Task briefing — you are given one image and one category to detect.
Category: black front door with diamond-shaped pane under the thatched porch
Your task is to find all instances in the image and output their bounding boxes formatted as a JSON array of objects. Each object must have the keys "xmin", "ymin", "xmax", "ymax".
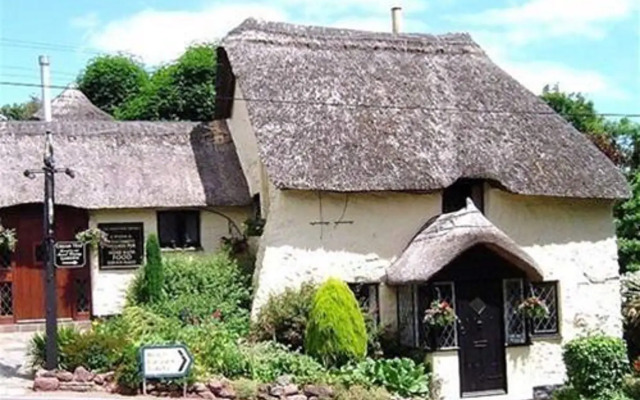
[{"xmin": 456, "ymin": 281, "xmax": 507, "ymax": 395}]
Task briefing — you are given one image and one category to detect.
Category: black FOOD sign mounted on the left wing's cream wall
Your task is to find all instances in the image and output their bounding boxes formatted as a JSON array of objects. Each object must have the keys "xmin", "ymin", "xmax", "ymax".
[{"xmin": 98, "ymin": 223, "xmax": 144, "ymax": 269}]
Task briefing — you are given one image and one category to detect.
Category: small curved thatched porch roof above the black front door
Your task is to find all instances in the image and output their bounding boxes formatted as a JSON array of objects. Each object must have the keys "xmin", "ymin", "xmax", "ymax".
[{"xmin": 387, "ymin": 200, "xmax": 542, "ymax": 285}]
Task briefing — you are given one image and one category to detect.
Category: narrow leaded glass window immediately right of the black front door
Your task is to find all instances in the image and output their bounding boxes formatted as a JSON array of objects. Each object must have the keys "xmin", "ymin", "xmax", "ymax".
[{"xmin": 502, "ymin": 279, "xmax": 527, "ymax": 345}]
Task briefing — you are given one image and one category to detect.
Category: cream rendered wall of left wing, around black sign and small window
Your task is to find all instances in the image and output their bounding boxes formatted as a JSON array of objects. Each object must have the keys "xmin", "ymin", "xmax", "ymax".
[{"xmin": 89, "ymin": 207, "xmax": 251, "ymax": 316}]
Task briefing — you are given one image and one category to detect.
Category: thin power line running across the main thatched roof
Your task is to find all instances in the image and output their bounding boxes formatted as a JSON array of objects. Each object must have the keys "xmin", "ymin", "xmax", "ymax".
[{"xmin": 0, "ymin": 81, "xmax": 640, "ymax": 118}]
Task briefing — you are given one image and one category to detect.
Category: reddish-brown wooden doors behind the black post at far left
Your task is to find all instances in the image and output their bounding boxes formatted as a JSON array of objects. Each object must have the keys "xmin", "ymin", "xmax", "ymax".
[{"xmin": 0, "ymin": 205, "xmax": 90, "ymax": 322}]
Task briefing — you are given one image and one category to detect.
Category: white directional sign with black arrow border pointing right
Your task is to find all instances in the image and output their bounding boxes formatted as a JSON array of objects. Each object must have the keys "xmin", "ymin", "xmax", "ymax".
[{"xmin": 141, "ymin": 345, "xmax": 193, "ymax": 378}]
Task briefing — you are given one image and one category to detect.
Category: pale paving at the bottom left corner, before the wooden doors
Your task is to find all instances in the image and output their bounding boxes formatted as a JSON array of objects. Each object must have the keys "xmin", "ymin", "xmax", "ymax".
[{"xmin": 0, "ymin": 332, "xmax": 33, "ymax": 398}]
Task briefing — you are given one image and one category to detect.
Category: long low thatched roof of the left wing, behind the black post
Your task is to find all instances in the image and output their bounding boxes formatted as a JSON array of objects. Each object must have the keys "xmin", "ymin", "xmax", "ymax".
[{"xmin": 0, "ymin": 121, "xmax": 250, "ymax": 209}]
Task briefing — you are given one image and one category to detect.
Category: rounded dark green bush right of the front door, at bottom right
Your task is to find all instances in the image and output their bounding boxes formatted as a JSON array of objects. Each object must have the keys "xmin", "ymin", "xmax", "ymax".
[{"xmin": 563, "ymin": 335, "xmax": 630, "ymax": 398}]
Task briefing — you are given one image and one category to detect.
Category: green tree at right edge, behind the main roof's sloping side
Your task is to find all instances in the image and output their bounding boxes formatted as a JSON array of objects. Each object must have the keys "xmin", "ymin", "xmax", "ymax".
[{"xmin": 541, "ymin": 86, "xmax": 640, "ymax": 273}]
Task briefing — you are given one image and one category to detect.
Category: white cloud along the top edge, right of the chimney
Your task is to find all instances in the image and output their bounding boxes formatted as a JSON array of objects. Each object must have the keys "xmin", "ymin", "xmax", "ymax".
[{"xmin": 450, "ymin": 0, "xmax": 638, "ymax": 44}]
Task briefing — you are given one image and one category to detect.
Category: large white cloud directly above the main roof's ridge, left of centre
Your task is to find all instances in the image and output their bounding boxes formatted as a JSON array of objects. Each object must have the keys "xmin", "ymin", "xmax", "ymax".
[{"xmin": 79, "ymin": 0, "xmax": 426, "ymax": 65}]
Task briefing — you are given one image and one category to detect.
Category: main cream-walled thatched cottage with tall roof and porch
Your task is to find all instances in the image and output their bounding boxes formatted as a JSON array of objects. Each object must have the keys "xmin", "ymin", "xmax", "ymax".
[{"xmin": 217, "ymin": 20, "xmax": 629, "ymax": 400}]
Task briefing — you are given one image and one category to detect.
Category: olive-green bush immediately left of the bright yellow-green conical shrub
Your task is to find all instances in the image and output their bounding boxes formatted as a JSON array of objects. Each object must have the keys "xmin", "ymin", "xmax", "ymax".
[{"xmin": 251, "ymin": 283, "xmax": 317, "ymax": 350}]
